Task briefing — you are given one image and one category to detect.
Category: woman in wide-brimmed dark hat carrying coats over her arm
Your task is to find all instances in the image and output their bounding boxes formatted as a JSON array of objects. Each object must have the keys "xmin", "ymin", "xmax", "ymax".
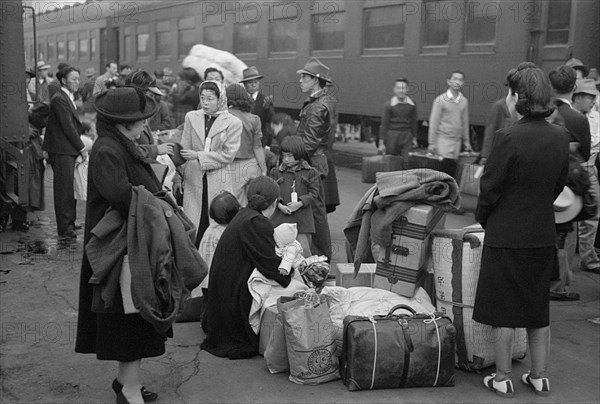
[{"xmin": 75, "ymin": 87, "xmax": 165, "ymax": 403}]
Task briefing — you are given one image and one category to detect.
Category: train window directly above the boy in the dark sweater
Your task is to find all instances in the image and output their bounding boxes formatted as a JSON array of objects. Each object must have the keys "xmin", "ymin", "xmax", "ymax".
[{"xmin": 363, "ymin": 5, "xmax": 405, "ymax": 49}]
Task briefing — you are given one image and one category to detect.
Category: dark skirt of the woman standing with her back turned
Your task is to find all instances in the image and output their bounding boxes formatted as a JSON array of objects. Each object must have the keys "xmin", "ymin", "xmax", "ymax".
[{"xmin": 473, "ymin": 245, "xmax": 557, "ymax": 328}]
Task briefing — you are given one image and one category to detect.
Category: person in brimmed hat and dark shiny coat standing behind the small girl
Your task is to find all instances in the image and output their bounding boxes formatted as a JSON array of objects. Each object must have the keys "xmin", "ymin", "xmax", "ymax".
[{"xmin": 296, "ymin": 57, "xmax": 339, "ymax": 257}]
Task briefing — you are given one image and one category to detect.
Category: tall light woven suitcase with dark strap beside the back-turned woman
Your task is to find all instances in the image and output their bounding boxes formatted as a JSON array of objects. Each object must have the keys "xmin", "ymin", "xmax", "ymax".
[{"xmin": 432, "ymin": 225, "xmax": 527, "ymax": 370}]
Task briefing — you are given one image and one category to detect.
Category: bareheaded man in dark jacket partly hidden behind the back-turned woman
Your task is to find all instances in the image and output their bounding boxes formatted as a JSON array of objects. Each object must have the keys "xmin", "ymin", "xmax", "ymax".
[{"xmin": 548, "ymin": 65, "xmax": 591, "ymax": 301}]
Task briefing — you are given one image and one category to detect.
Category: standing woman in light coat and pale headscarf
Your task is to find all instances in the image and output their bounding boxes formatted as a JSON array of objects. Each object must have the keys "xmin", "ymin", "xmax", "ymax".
[{"xmin": 181, "ymin": 80, "xmax": 242, "ymax": 245}]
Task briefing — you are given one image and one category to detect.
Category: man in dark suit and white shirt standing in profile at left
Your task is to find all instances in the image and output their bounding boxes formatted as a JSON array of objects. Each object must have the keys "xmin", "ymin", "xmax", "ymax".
[{"xmin": 43, "ymin": 67, "xmax": 87, "ymax": 238}]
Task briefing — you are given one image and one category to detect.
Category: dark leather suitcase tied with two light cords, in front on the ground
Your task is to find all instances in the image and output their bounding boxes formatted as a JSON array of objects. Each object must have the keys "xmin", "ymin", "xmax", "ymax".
[{"xmin": 341, "ymin": 304, "xmax": 456, "ymax": 391}]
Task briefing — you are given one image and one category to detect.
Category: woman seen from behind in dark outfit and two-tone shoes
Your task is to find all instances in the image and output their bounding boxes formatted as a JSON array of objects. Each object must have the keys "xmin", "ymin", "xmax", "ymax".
[{"xmin": 473, "ymin": 66, "xmax": 569, "ymax": 397}]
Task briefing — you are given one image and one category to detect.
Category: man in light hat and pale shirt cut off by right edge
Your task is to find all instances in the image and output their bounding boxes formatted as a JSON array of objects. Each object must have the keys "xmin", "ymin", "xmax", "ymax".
[{"xmin": 573, "ymin": 79, "xmax": 600, "ymax": 274}]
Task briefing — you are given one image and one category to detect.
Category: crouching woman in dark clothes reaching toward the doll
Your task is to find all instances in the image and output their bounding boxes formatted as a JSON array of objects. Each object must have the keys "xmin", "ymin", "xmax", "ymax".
[{"xmin": 201, "ymin": 176, "xmax": 293, "ymax": 359}]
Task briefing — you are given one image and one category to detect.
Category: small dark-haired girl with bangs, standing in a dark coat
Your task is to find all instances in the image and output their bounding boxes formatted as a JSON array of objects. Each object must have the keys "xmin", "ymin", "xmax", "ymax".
[{"xmin": 270, "ymin": 136, "xmax": 321, "ymax": 256}]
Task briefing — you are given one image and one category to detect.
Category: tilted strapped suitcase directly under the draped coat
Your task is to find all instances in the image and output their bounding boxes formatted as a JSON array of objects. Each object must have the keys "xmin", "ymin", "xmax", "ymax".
[{"xmin": 373, "ymin": 204, "xmax": 445, "ymax": 297}]
